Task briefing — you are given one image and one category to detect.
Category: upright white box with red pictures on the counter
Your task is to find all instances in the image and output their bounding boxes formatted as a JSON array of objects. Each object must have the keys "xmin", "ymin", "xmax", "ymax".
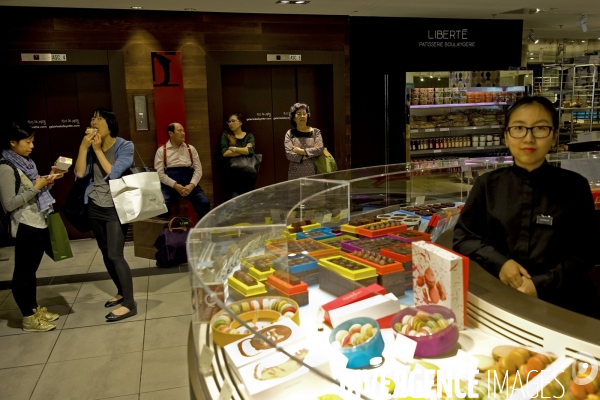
[{"xmin": 412, "ymin": 241, "xmax": 469, "ymax": 326}]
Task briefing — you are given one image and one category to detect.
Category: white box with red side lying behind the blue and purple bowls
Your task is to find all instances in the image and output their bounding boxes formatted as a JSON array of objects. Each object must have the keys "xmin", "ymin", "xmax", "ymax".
[{"xmin": 329, "ymin": 293, "xmax": 400, "ymax": 329}]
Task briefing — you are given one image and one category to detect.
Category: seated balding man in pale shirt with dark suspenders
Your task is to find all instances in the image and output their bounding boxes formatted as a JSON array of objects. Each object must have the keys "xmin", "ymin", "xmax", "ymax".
[{"xmin": 154, "ymin": 122, "xmax": 210, "ymax": 221}]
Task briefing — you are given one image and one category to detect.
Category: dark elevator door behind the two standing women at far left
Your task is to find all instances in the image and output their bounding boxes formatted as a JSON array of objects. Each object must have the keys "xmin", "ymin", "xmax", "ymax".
[{"xmin": 2, "ymin": 66, "xmax": 111, "ymax": 239}]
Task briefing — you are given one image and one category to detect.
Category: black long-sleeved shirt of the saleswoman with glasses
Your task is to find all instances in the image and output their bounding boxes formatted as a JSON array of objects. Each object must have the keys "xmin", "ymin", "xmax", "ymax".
[{"xmin": 453, "ymin": 162, "xmax": 600, "ymax": 314}]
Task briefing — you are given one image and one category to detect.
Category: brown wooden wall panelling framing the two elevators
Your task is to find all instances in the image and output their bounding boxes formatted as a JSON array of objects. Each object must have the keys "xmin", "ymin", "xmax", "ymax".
[{"xmin": 0, "ymin": 7, "xmax": 350, "ymax": 209}]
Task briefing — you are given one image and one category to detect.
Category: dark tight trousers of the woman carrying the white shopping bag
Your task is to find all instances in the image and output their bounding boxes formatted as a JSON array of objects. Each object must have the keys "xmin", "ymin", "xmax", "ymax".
[{"xmin": 87, "ymin": 200, "xmax": 135, "ymax": 310}]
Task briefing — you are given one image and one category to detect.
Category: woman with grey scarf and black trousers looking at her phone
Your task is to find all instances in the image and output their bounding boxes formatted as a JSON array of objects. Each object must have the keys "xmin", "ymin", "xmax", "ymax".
[{"xmin": 0, "ymin": 121, "xmax": 66, "ymax": 332}]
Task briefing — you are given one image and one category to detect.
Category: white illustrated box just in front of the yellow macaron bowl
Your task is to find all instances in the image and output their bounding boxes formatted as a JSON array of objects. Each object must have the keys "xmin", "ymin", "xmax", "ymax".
[{"xmin": 223, "ymin": 318, "xmax": 306, "ymax": 368}]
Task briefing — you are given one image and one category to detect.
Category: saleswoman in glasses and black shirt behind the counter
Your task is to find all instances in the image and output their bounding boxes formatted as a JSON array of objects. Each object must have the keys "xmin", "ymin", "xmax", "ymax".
[{"xmin": 454, "ymin": 97, "xmax": 600, "ymax": 318}]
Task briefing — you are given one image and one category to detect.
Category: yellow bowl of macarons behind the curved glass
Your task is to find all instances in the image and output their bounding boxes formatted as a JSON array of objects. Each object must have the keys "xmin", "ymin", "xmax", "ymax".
[{"xmin": 210, "ymin": 296, "xmax": 300, "ymax": 347}]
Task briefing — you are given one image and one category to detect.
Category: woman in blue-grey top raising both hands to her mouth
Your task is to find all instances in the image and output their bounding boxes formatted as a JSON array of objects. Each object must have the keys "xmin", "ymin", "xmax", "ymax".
[{"xmin": 75, "ymin": 108, "xmax": 137, "ymax": 322}]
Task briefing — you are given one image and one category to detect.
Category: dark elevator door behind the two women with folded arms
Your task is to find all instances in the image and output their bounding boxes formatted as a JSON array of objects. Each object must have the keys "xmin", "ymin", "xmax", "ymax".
[{"xmin": 218, "ymin": 65, "xmax": 334, "ymax": 188}]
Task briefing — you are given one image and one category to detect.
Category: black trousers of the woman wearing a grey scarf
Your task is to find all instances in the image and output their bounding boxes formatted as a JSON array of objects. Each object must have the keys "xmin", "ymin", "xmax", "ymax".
[{"xmin": 12, "ymin": 224, "xmax": 52, "ymax": 317}]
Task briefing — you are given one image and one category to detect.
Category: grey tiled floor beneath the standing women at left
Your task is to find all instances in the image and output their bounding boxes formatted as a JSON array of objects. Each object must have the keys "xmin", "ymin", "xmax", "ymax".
[{"xmin": 0, "ymin": 241, "xmax": 191, "ymax": 400}]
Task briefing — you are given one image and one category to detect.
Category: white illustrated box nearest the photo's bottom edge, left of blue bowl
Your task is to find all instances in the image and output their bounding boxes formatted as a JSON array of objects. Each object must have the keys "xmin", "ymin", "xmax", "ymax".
[{"xmin": 240, "ymin": 341, "xmax": 331, "ymax": 400}]
